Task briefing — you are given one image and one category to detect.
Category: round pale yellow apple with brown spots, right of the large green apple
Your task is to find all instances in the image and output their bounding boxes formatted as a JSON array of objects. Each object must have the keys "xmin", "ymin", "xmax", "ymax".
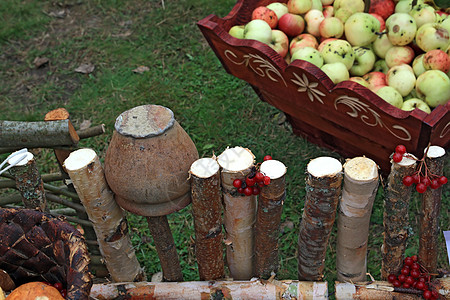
[{"xmin": 386, "ymin": 13, "xmax": 417, "ymax": 46}]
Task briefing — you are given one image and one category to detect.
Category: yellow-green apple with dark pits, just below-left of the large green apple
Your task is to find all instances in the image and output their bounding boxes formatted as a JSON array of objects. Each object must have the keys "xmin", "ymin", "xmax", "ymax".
[{"xmin": 320, "ymin": 39, "xmax": 355, "ymax": 70}]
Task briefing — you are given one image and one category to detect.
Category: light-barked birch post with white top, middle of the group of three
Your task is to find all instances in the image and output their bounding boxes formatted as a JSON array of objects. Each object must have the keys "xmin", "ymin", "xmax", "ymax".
[{"xmin": 217, "ymin": 147, "xmax": 256, "ymax": 280}]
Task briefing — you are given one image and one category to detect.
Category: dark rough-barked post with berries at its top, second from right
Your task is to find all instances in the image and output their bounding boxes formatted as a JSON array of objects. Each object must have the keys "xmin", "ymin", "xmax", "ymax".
[{"xmin": 381, "ymin": 154, "xmax": 417, "ymax": 280}]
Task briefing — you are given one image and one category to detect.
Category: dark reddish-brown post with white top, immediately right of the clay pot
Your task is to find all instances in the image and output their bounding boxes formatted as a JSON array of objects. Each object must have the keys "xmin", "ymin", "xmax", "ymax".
[{"xmin": 190, "ymin": 158, "xmax": 225, "ymax": 280}]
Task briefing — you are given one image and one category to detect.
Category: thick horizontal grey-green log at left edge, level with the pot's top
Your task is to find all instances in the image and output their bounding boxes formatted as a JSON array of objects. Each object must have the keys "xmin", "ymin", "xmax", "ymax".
[{"xmin": 0, "ymin": 120, "xmax": 80, "ymax": 148}]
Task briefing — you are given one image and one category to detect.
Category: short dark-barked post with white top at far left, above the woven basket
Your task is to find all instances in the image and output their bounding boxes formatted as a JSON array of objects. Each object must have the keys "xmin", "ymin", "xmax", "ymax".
[{"xmin": 8, "ymin": 152, "xmax": 47, "ymax": 211}]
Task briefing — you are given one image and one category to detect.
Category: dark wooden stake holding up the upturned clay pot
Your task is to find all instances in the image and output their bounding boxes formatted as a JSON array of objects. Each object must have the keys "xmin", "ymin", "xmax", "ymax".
[{"xmin": 147, "ymin": 216, "xmax": 183, "ymax": 281}]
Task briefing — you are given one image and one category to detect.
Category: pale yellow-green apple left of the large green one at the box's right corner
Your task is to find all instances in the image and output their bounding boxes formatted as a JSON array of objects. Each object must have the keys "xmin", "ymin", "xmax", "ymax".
[{"xmin": 386, "ymin": 64, "xmax": 416, "ymax": 97}]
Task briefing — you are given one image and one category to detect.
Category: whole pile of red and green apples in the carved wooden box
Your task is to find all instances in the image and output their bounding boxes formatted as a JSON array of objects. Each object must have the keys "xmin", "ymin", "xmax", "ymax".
[{"xmin": 229, "ymin": 0, "xmax": 450, "ymax": 113}]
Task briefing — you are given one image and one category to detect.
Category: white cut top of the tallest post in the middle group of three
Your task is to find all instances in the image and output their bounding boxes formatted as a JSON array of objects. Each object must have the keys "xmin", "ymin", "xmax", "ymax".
[{"xmin": 217, "ymin": 146, "xmax": 255, "ymax": 172}]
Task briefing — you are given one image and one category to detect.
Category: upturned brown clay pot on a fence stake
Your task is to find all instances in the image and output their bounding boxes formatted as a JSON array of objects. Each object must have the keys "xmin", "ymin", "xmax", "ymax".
[{"xmin": 105, "ymin": 105, "xmax": 198, "ymax": 216}]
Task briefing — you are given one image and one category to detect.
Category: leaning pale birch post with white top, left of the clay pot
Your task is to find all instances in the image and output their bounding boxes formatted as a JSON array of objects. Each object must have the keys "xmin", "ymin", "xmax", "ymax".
[{"xmin": 64, "ymin": 149, "xmax": 145, "ymax": 281}]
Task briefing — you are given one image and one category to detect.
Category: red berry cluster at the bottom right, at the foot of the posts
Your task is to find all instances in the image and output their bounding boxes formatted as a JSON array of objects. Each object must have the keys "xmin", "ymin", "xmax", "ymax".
[{"xmin": 388, "ymin": 255, "xmax": 439, "ymax": 300}]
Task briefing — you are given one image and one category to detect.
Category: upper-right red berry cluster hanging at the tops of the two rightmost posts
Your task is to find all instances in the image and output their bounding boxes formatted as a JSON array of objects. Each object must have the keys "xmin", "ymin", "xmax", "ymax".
[{"xmin": 392, "ymin": 145, "xmax": 448, "ymax": 194}]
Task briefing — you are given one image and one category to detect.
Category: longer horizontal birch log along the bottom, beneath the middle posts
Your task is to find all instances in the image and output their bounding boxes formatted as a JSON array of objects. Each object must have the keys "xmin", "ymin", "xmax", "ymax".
[{"xmin": 90, "ymin": 280, "xmax": 328, "ymax": 300}]
